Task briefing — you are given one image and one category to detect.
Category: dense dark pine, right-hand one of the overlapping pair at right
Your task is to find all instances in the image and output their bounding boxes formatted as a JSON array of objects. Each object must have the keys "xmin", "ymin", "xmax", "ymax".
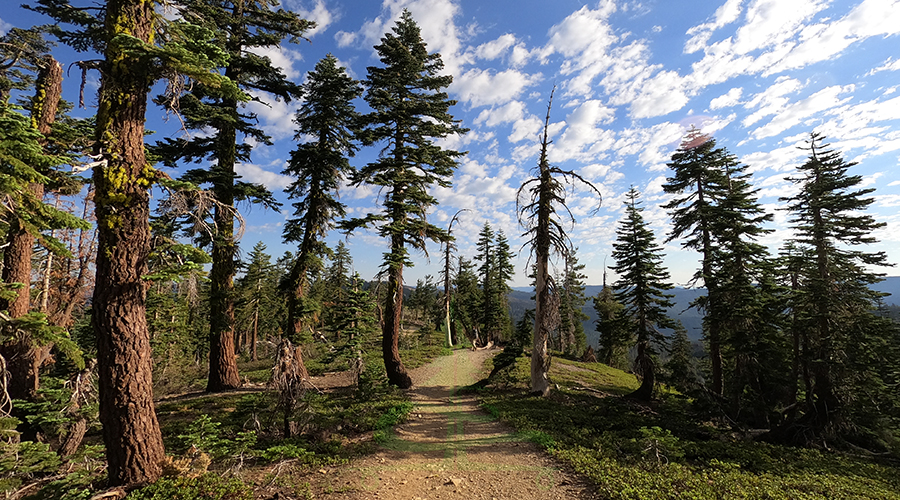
[{"xmin": 707, "ymin": 153, "xmax": 786, "ymax": 426}]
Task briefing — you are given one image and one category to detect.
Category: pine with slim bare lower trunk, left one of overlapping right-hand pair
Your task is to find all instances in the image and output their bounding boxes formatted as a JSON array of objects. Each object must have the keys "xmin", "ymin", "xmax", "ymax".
[{"xmin": 663, "ymin": 128, "xmax": 730, "ymax": 395}]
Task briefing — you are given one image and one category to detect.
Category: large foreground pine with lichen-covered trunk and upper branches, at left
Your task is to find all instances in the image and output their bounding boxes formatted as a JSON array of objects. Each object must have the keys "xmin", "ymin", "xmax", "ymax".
[{"xmin": 34, "ymin": 0, "xmax": 237, "ymax": 485}]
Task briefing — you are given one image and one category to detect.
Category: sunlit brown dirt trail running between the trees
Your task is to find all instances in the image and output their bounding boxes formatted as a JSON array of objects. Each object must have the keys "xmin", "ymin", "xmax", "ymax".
[{"xmin": 311, "ymin": 350, "xmax": 591, "ymax": 500}]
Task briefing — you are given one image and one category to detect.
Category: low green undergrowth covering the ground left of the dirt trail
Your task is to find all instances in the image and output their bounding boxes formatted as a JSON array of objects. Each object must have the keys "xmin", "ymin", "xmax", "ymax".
[{"xmin": 157, "ymin": 331, "xmax": 452, "ymax": 471}]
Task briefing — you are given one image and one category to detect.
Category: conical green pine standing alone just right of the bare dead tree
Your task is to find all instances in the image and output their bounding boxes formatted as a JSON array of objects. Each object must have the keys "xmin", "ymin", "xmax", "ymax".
[{"xmin": 612, "ymin": 186, "xmax": 675, "ymax": 400}]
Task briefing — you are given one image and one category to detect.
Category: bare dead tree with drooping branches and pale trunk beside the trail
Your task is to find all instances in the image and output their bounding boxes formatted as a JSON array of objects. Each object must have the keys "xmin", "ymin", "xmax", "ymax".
[{"xmin": 516, "ymin": 87, "xmax": 602, "ymax": 396}]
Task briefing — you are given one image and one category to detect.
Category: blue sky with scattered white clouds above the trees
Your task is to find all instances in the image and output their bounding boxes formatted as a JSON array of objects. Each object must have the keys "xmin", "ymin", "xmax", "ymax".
[{"xmin": 0, "ymin": 0, "xmax": 900, "ymax": 286}]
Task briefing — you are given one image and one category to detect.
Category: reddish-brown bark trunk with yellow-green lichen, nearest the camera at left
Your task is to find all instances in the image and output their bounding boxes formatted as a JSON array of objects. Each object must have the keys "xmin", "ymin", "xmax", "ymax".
[{"xmin": 91, "ymin": 0, "xmax": 165, "ymax": 485}]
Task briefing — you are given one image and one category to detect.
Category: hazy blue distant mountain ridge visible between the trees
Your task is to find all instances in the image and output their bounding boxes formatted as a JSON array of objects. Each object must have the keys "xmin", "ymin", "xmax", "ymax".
[{"xmin": 508, "ymin": 276, "xmax": 900, "ymax": 346}]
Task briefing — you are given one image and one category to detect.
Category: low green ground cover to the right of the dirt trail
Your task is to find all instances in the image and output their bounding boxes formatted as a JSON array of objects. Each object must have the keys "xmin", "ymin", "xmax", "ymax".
[{"xmin": 480, "ymin": 357, "xmax": 900, "ymax": 500}]
